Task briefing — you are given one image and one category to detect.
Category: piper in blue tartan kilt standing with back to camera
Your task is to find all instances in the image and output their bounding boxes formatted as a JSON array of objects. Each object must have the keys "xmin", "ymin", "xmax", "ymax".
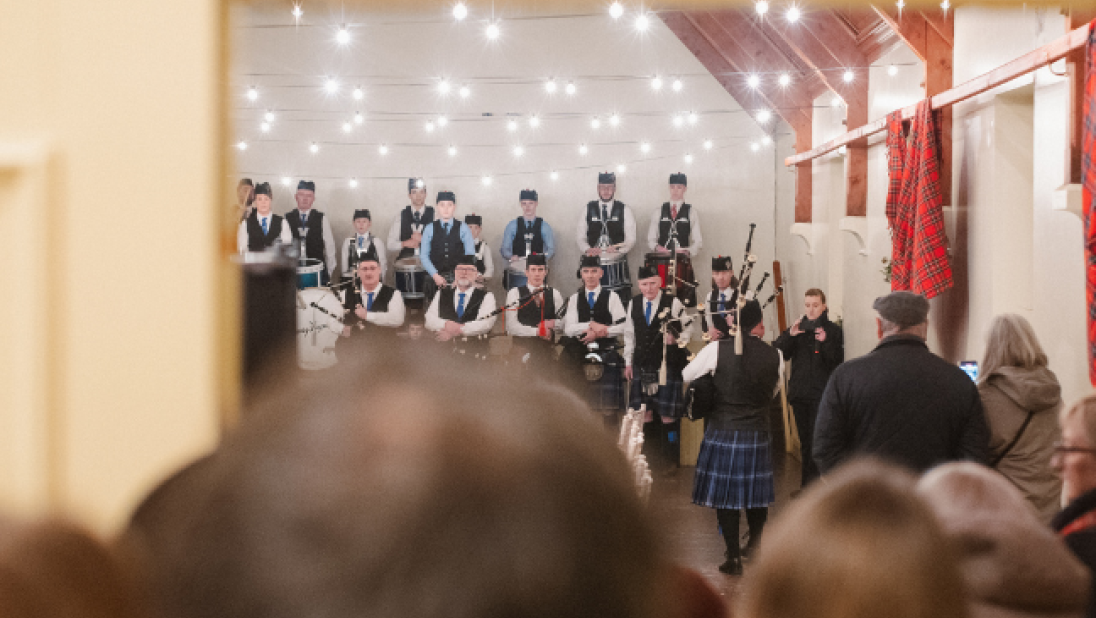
[{"xmin": 683, "ymin": 300, "xmax": 784, "ymax": 575}]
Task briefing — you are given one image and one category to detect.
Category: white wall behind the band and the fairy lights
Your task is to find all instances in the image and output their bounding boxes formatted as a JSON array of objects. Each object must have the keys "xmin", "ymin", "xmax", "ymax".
[{"xmin": 232, "ymin": 9, "xmax": 786, "ymax": 306}]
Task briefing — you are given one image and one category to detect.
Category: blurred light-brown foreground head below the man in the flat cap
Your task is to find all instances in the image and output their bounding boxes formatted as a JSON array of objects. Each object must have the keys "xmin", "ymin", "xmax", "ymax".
[{"xmin": 735, "ymin": 460, "xmax": 967, "ymax": 618}]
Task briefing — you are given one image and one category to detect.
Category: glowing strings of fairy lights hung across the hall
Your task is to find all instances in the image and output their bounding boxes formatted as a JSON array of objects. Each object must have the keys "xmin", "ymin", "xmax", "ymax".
[{"xmin": 235, "ymin": 0, "xmax": 933, "ymax": 182}]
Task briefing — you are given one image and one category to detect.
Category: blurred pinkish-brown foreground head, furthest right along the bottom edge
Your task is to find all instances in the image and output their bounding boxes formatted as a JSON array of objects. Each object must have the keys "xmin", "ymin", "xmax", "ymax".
[{"xmin": 917, "ymin": 462, "xmax": 1088, "ymax": 617}]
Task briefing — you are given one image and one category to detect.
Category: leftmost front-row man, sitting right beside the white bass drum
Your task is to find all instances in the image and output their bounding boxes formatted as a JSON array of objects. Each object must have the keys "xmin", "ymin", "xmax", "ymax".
[{"xmin": 342, "ymin": 253, "xmax": 407, "ymax": 345}]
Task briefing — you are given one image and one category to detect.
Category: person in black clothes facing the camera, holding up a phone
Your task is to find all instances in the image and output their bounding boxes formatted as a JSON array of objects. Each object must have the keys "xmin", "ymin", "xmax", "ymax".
[{"xmin": 773, "ymin": 288, "xmax": 845, "ymax": 487}]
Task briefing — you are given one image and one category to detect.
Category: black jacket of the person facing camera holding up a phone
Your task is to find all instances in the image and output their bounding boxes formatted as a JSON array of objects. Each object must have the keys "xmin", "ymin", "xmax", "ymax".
[{"xmin": 773, "ymin": 311, "xmax": 845, "ymax": 401}]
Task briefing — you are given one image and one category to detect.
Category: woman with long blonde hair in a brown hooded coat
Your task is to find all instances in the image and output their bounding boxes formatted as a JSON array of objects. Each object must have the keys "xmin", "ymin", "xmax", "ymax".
[{"xmin": 978, "ymin": 313, "xmax": 1062, "ymax": 524}]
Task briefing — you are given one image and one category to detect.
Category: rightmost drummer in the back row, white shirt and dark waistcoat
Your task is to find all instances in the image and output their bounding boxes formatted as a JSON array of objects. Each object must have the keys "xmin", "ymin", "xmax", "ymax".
[{"xmin": 647, "ymin": 172, "xmax": 704, "ymax": 307}]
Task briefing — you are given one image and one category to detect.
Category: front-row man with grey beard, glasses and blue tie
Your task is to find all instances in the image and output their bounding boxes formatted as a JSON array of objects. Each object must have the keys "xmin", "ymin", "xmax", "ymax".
[{"xmin": 426, "ymin": 253, "xmax": 498, "ymax": 358}]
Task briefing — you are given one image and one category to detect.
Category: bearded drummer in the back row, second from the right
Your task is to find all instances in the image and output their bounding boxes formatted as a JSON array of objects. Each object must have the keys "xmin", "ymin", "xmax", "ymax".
[{"xmin": 575, "ymin": 172, "xmax": 636, "ymax": 302}]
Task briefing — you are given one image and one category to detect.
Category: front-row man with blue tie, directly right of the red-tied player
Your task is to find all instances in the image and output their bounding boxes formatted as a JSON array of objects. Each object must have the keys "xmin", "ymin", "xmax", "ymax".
[{"xmin": 563, "ymin": 255, "xmax": 627, "ymax": 422}]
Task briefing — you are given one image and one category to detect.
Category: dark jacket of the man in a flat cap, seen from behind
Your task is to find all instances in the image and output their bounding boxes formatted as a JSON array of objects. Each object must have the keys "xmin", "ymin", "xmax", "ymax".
[{"xmin": 814, "ymin": 335, "xmax": 990, "ymax": 473}]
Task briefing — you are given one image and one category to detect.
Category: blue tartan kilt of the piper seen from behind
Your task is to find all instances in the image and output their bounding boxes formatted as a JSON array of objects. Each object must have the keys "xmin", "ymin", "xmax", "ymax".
[{"xmin": 693, "ymin": 427, "xmax": 776, "ymax": 508}]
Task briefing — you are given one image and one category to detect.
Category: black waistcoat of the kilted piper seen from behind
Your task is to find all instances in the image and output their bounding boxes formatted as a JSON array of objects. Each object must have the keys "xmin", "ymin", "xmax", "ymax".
[{"xmin": 711, "ymin": 335, "xmax": 780, "ymax": 432}]
